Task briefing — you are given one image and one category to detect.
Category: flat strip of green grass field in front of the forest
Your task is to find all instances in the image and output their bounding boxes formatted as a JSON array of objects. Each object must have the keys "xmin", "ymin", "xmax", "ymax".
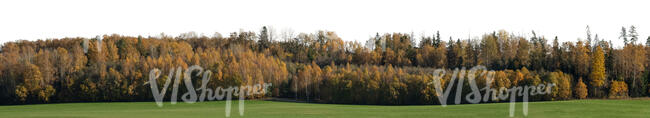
[{"xmin": 0, "ymin": 100, "xmax": 650, "ymax": 118}]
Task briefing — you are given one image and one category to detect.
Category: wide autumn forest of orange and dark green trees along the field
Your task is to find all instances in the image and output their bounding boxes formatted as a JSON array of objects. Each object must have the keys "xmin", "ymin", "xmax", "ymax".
[{"xmin": 0, "ymin": 27, "xmax": 650, "ymax": 104}]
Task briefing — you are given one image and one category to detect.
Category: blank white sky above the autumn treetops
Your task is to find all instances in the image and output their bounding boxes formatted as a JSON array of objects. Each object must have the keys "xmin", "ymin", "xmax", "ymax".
[{"xmin": 0, "ymin": 0, "xmax": 650, "ymax": 46}]
